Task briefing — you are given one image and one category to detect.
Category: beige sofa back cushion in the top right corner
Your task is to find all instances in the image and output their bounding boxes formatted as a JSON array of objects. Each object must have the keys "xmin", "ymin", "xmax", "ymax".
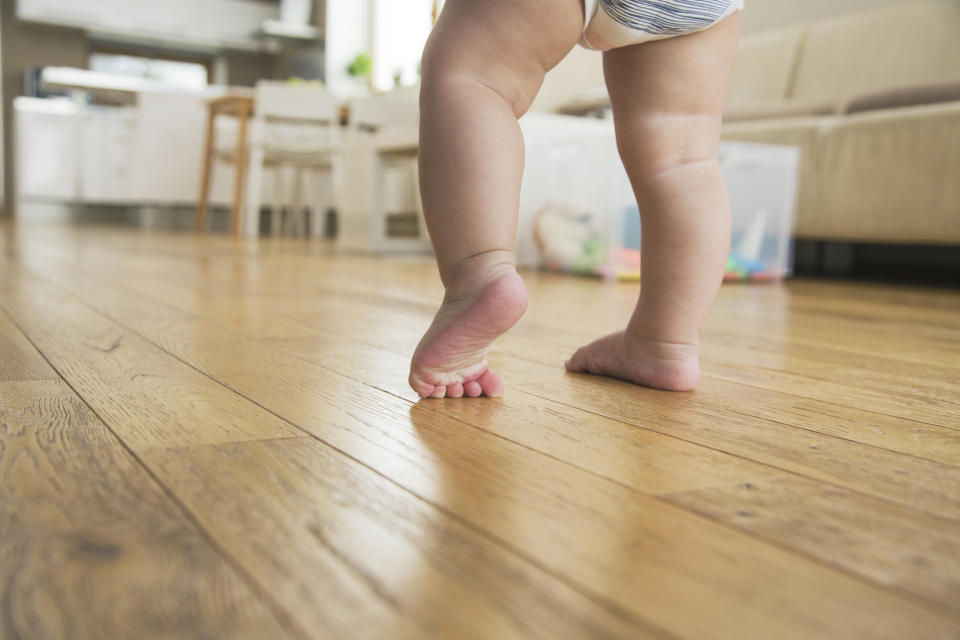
[{"xmin": 791, "ymin": 0, "xmax": 960, "ymax": 99}]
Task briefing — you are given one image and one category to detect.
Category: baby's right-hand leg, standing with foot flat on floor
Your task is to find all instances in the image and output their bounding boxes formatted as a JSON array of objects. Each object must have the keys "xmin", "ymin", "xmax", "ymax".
[{"xmin": 567, "ymin": 14, "xmax": 739, "ymax": 391}]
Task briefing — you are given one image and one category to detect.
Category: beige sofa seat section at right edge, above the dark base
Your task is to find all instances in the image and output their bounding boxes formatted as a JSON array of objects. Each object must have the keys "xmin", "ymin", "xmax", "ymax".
[{"xmin": 804, "ymin": 102, "xmax": 960, "ymax": 244}]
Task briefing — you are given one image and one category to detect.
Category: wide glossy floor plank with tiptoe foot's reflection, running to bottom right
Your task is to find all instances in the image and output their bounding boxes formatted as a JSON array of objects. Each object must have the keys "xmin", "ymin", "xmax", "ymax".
[{"xmin": 13, "ymin": 258, "xmax": 956, "ymax": 637}]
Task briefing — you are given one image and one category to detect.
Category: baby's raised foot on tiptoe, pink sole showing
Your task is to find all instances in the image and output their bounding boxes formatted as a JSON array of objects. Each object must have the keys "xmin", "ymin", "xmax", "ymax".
[{"xmin": 409, "ymin": 265, "xmax": 527, "ymax": 398}]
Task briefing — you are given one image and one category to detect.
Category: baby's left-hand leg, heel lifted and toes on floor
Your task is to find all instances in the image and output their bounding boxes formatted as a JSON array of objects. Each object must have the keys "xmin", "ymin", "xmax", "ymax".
[{"xmin": 410, "ymin": 0, "xmax": 583, "ymax": 397}]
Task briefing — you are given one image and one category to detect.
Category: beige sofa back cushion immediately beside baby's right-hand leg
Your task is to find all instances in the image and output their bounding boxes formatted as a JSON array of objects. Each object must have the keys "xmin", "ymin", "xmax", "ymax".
[{"xmin": 727, "ymin": 25, "xmax": 806, "ymax": 106}]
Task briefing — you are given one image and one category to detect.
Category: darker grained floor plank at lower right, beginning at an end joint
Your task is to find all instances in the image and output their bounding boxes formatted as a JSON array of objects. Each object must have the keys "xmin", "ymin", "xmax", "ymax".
[{"xmin": 670, "ymin": 476, "xmax": 960, "ymax": 611}]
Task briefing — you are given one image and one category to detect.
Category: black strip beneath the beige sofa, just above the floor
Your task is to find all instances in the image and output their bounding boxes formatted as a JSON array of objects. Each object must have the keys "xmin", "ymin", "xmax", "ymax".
[{"xmin": 793, "ymin": 239, "xmax": 960, "ymax": 289}]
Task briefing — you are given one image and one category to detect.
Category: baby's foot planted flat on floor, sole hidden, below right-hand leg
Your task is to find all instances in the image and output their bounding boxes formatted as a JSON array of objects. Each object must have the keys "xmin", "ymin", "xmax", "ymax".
[{"xmin": 565, "ymin": 331, "xmax": 700, "ymax": 391}]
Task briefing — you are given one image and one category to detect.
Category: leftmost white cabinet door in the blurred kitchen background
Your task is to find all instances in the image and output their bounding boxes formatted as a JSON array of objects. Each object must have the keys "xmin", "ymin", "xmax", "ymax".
[{"xmin": 16, "ymin": 111, "xmax": 79, "ymax": 200}]
